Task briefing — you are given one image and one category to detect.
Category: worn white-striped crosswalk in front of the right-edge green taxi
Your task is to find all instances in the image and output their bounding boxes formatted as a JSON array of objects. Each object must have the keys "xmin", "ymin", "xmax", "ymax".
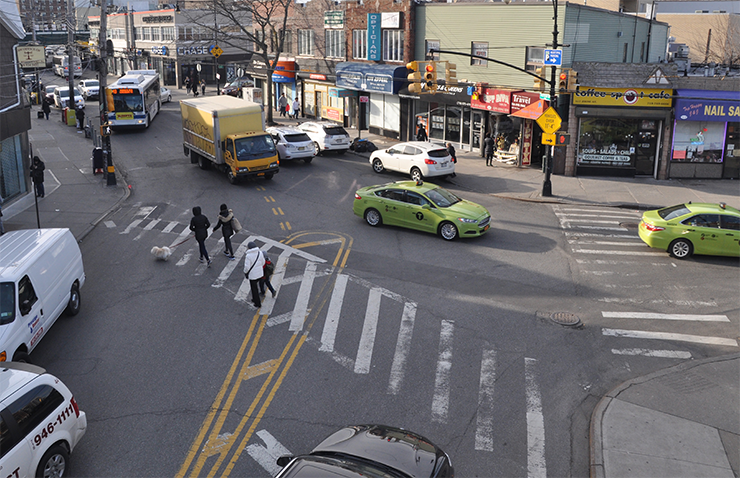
[{"xmin": 553, "ymin": 205, "xmax": 738, "ymax": 359}]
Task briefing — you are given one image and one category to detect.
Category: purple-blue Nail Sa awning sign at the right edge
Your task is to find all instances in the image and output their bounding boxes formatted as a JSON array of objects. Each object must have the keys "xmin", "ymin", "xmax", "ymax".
[{"xmin": 676, "ymin": 90, "xmax": 740, "ymax": 122}]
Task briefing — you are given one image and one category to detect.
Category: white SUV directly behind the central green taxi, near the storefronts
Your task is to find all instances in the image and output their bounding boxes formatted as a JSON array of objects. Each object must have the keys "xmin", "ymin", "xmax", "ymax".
[{"xmin": 370, "ymin": 141, "xmax": 455, "ymax": 181}]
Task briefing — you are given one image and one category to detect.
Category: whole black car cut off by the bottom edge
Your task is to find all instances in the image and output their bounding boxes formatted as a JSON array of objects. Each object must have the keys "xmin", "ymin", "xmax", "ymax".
[{"xmin": 275, "ymin": 425, "xmax": 455, "ymax": 478}]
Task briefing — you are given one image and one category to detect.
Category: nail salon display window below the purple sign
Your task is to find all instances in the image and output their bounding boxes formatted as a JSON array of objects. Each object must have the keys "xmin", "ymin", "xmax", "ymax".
[{"xmin": 671, "ymin": 121, "xmax": 725, "ymax": 163}]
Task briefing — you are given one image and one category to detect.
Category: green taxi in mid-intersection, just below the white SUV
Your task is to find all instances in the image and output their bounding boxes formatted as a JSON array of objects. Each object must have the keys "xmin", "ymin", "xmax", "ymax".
[{"xmin": 352, "ymin": 181, "xmax": 491, "ymax": 241}]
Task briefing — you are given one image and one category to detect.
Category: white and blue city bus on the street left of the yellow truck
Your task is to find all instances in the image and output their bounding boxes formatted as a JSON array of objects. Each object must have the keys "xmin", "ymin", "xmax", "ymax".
[{"xmin": 105, "ymin": 70, "xmax": 160, "ymax": 130}]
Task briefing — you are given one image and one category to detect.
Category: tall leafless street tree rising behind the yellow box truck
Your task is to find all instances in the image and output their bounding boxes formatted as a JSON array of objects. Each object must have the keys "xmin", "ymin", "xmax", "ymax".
[{"xmin": 186, "ymin": 0, "xmax": 294, "ymax": 125}]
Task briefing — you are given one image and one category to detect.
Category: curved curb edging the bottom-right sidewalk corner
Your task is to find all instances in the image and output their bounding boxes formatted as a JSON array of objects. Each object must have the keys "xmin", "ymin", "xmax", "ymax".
[{"xmin": 589, "ymin": 353, "xmax": 740, "ymax": 478}]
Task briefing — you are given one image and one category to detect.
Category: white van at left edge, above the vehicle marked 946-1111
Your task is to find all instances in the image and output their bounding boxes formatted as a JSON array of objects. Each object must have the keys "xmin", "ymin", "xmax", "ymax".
[{"xmin": 0, "ymin": 229, "xmax": 85, "ymax": 362}]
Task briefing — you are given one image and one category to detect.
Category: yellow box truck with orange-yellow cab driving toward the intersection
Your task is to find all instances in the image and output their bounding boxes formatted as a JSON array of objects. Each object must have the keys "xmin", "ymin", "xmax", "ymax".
[{"xmin": 180, "ymin": 95, "xmax": 280, "ymax": 184}]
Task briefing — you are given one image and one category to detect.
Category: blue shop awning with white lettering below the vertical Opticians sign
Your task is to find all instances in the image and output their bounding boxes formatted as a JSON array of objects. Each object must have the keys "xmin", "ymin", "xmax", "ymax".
[{"xmin": 336, "ymin": 61, "xmax": 408, "ymax": 95}]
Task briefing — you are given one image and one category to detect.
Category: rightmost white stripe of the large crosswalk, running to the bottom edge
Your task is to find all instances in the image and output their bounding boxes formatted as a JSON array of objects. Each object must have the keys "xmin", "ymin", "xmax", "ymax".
[{"xmin": 524, "ymin": 358, "xmax": 547, "ymax": 478}]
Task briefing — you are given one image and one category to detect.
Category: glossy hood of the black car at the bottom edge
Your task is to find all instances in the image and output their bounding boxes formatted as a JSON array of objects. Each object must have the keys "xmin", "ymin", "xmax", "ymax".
[{"xmin": 311, "ymin": 425, "xmax": 446, "ymax": 478}]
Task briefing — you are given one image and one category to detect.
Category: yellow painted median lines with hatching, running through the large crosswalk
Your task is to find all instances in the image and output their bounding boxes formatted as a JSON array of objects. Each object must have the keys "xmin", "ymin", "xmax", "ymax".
[{"xmin": 175, "ymin": 232, "xmax": 353, "ymax": 478}]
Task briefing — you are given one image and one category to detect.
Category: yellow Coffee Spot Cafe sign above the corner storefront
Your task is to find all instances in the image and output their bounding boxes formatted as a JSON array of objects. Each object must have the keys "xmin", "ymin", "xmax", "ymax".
[{"xmin": 573, "ymin": 88, "xmax": 673, "ymax": 108}]
